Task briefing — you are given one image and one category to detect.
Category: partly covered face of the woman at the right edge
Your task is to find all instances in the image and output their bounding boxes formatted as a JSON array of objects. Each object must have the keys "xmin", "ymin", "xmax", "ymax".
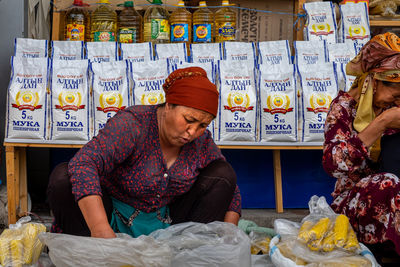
[{"xmin": 374, "ymin": 80, "xmax": 400, "ymax": 109}]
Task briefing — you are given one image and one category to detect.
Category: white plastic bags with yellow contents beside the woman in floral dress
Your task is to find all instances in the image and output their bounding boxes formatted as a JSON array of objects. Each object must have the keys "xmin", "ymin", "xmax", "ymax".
[{"xmin": 270, "ymin": 196, "xmax": 379, "ymax": 267}]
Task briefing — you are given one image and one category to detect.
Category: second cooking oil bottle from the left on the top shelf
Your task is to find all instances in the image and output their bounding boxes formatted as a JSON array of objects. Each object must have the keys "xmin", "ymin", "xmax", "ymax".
[{"xmin": 90, "ymin": 0, "xmax": 117, "ymax": 42}]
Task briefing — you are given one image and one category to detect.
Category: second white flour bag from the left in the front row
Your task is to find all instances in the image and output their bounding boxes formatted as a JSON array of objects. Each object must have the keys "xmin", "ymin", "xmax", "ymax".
[{"xmin": 50, "ymin": 60, "xmax": 90, "ymax": 141}]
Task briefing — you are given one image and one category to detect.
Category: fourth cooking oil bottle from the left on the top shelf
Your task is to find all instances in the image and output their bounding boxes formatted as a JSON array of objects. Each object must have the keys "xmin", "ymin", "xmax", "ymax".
[{"xmin": 143, "ymin": 0, "xmax": 170, "ymax": 43}]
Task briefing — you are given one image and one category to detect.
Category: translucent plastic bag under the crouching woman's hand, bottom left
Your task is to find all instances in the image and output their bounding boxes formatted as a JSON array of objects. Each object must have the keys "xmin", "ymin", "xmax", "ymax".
[{"xmin": 39, "ymin": 233, "xmax": 171, "ymax": 267}]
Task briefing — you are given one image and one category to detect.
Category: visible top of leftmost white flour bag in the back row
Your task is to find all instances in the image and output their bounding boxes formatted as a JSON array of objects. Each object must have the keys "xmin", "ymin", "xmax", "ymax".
[{"xmin": 14, "ymin": 38, "xmax": 48, "ymax": 58}]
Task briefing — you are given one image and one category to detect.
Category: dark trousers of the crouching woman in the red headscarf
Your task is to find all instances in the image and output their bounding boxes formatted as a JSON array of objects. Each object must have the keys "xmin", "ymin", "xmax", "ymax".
[{"xmin": 47, "ymin": 160, "xmax": 236, "ymax": 236}]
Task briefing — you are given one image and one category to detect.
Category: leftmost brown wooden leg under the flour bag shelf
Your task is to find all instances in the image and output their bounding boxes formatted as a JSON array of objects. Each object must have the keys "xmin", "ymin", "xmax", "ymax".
[{"xmin": 6, "ymin": 146, "xmax": 17, "ymax": 224}]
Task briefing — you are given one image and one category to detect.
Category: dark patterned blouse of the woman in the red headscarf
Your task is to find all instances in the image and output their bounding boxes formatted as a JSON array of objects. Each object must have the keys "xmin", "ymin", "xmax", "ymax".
[{"xmin": 68, "ymin": 106, "xmax": 241, "ymax": 214}]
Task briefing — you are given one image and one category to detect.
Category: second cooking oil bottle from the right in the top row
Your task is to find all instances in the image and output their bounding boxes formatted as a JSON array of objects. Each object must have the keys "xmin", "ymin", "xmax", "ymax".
[{"xmin": 193, "ymin": 1, "xmax": 214, "ymax": 43}]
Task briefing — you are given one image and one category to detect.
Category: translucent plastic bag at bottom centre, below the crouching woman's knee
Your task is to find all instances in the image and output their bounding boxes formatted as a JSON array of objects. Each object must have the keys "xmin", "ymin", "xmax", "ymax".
[{"xmin": 150, "ymin": 222, "xmax": 251, "ymax": 267}]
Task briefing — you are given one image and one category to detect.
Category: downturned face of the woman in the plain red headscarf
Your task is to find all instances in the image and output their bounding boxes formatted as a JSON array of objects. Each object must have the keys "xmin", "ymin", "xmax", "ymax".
[{"xmin": 161, "ymin": 103, "xmax": 214, "ymax": 147}]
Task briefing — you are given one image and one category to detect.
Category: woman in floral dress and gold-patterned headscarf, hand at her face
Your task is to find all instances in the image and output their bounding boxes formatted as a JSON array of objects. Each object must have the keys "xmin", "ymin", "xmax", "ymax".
[{"xmin": 323, "ymin": 33, "xmax": 400, "ymax": 254}]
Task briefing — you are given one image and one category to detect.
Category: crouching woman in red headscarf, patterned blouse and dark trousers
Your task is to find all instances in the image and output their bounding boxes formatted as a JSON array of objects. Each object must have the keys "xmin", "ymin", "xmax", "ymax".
[{"xmin": 48, "ymin": 67, "xmax": 241, "ymax": 238}]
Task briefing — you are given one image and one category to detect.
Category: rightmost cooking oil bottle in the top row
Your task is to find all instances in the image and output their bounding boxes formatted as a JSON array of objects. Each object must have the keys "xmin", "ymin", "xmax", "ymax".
[{"xmin": 215, "ymin": 0, "xmax": 236, "ymax": 43}]
